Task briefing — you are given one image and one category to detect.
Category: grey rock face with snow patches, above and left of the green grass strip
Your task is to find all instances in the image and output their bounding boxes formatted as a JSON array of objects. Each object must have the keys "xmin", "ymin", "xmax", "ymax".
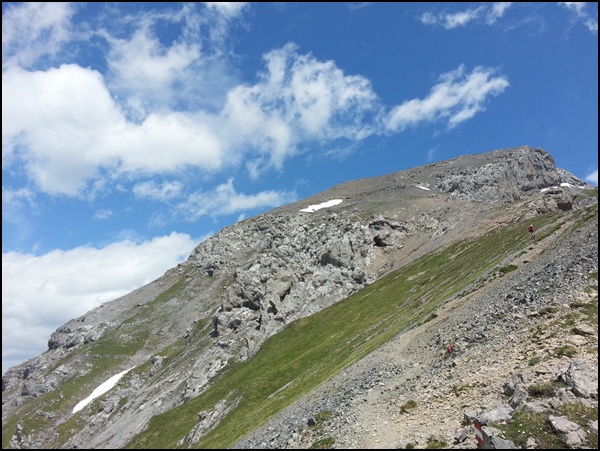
[{"xmin": 2, "ymin": 146, "xmax": 597, "ymax": 448}]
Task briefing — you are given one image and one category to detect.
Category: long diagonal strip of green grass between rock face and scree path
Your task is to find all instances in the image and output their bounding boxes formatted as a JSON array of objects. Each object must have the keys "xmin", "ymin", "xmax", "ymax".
[{"xmin": 128, "ymin": 215, "xmax": 557, "ymax": 449}]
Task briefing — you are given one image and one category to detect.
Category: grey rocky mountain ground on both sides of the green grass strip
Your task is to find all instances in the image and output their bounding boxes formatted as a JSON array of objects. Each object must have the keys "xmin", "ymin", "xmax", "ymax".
[{"xmin": 2, "ymin": 146, "xmax": 598, "ymax": 449}]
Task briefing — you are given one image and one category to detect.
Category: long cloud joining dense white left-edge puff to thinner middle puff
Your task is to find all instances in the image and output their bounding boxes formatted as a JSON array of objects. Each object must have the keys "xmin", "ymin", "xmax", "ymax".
[{"xmin": 2, "ymin": 41, "xmax": 376, "ymax": 196}]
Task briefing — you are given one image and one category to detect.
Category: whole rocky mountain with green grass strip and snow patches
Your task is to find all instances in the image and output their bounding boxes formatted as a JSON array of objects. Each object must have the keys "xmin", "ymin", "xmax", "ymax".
[{"xmin": 2, "ymin": 146, "xmax": 598, "ymax": 448}]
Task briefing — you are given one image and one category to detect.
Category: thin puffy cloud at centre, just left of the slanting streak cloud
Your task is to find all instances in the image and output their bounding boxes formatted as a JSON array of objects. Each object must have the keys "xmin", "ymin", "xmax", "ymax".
[{"xmin": 224, "ymin": 44, "xmax": 379, "ymax": 174}]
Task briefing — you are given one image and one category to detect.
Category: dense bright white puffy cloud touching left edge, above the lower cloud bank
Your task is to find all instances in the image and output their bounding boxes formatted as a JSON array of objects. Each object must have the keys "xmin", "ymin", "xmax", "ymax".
[{"xmin": 2, "ymin": 65, "xmax": 225, "ymax": 196}]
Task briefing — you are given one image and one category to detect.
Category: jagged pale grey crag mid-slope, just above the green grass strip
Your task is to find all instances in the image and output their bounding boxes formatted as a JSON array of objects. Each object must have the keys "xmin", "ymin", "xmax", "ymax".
[{"xmin": 213, "ymin": 214, "xmax": 374, "ymax": 358}]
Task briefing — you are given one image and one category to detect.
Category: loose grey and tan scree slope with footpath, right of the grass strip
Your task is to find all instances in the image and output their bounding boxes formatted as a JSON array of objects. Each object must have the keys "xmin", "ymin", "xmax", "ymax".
[{"xmin": 236, "ymin": 200, "xmax": 598, "ymax": 449}]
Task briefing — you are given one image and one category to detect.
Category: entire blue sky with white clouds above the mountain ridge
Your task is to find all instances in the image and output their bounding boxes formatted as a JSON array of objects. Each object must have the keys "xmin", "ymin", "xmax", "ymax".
[{"xmin": 2, "ymin": 2, "xmax": 598, "ymax": 373}]
